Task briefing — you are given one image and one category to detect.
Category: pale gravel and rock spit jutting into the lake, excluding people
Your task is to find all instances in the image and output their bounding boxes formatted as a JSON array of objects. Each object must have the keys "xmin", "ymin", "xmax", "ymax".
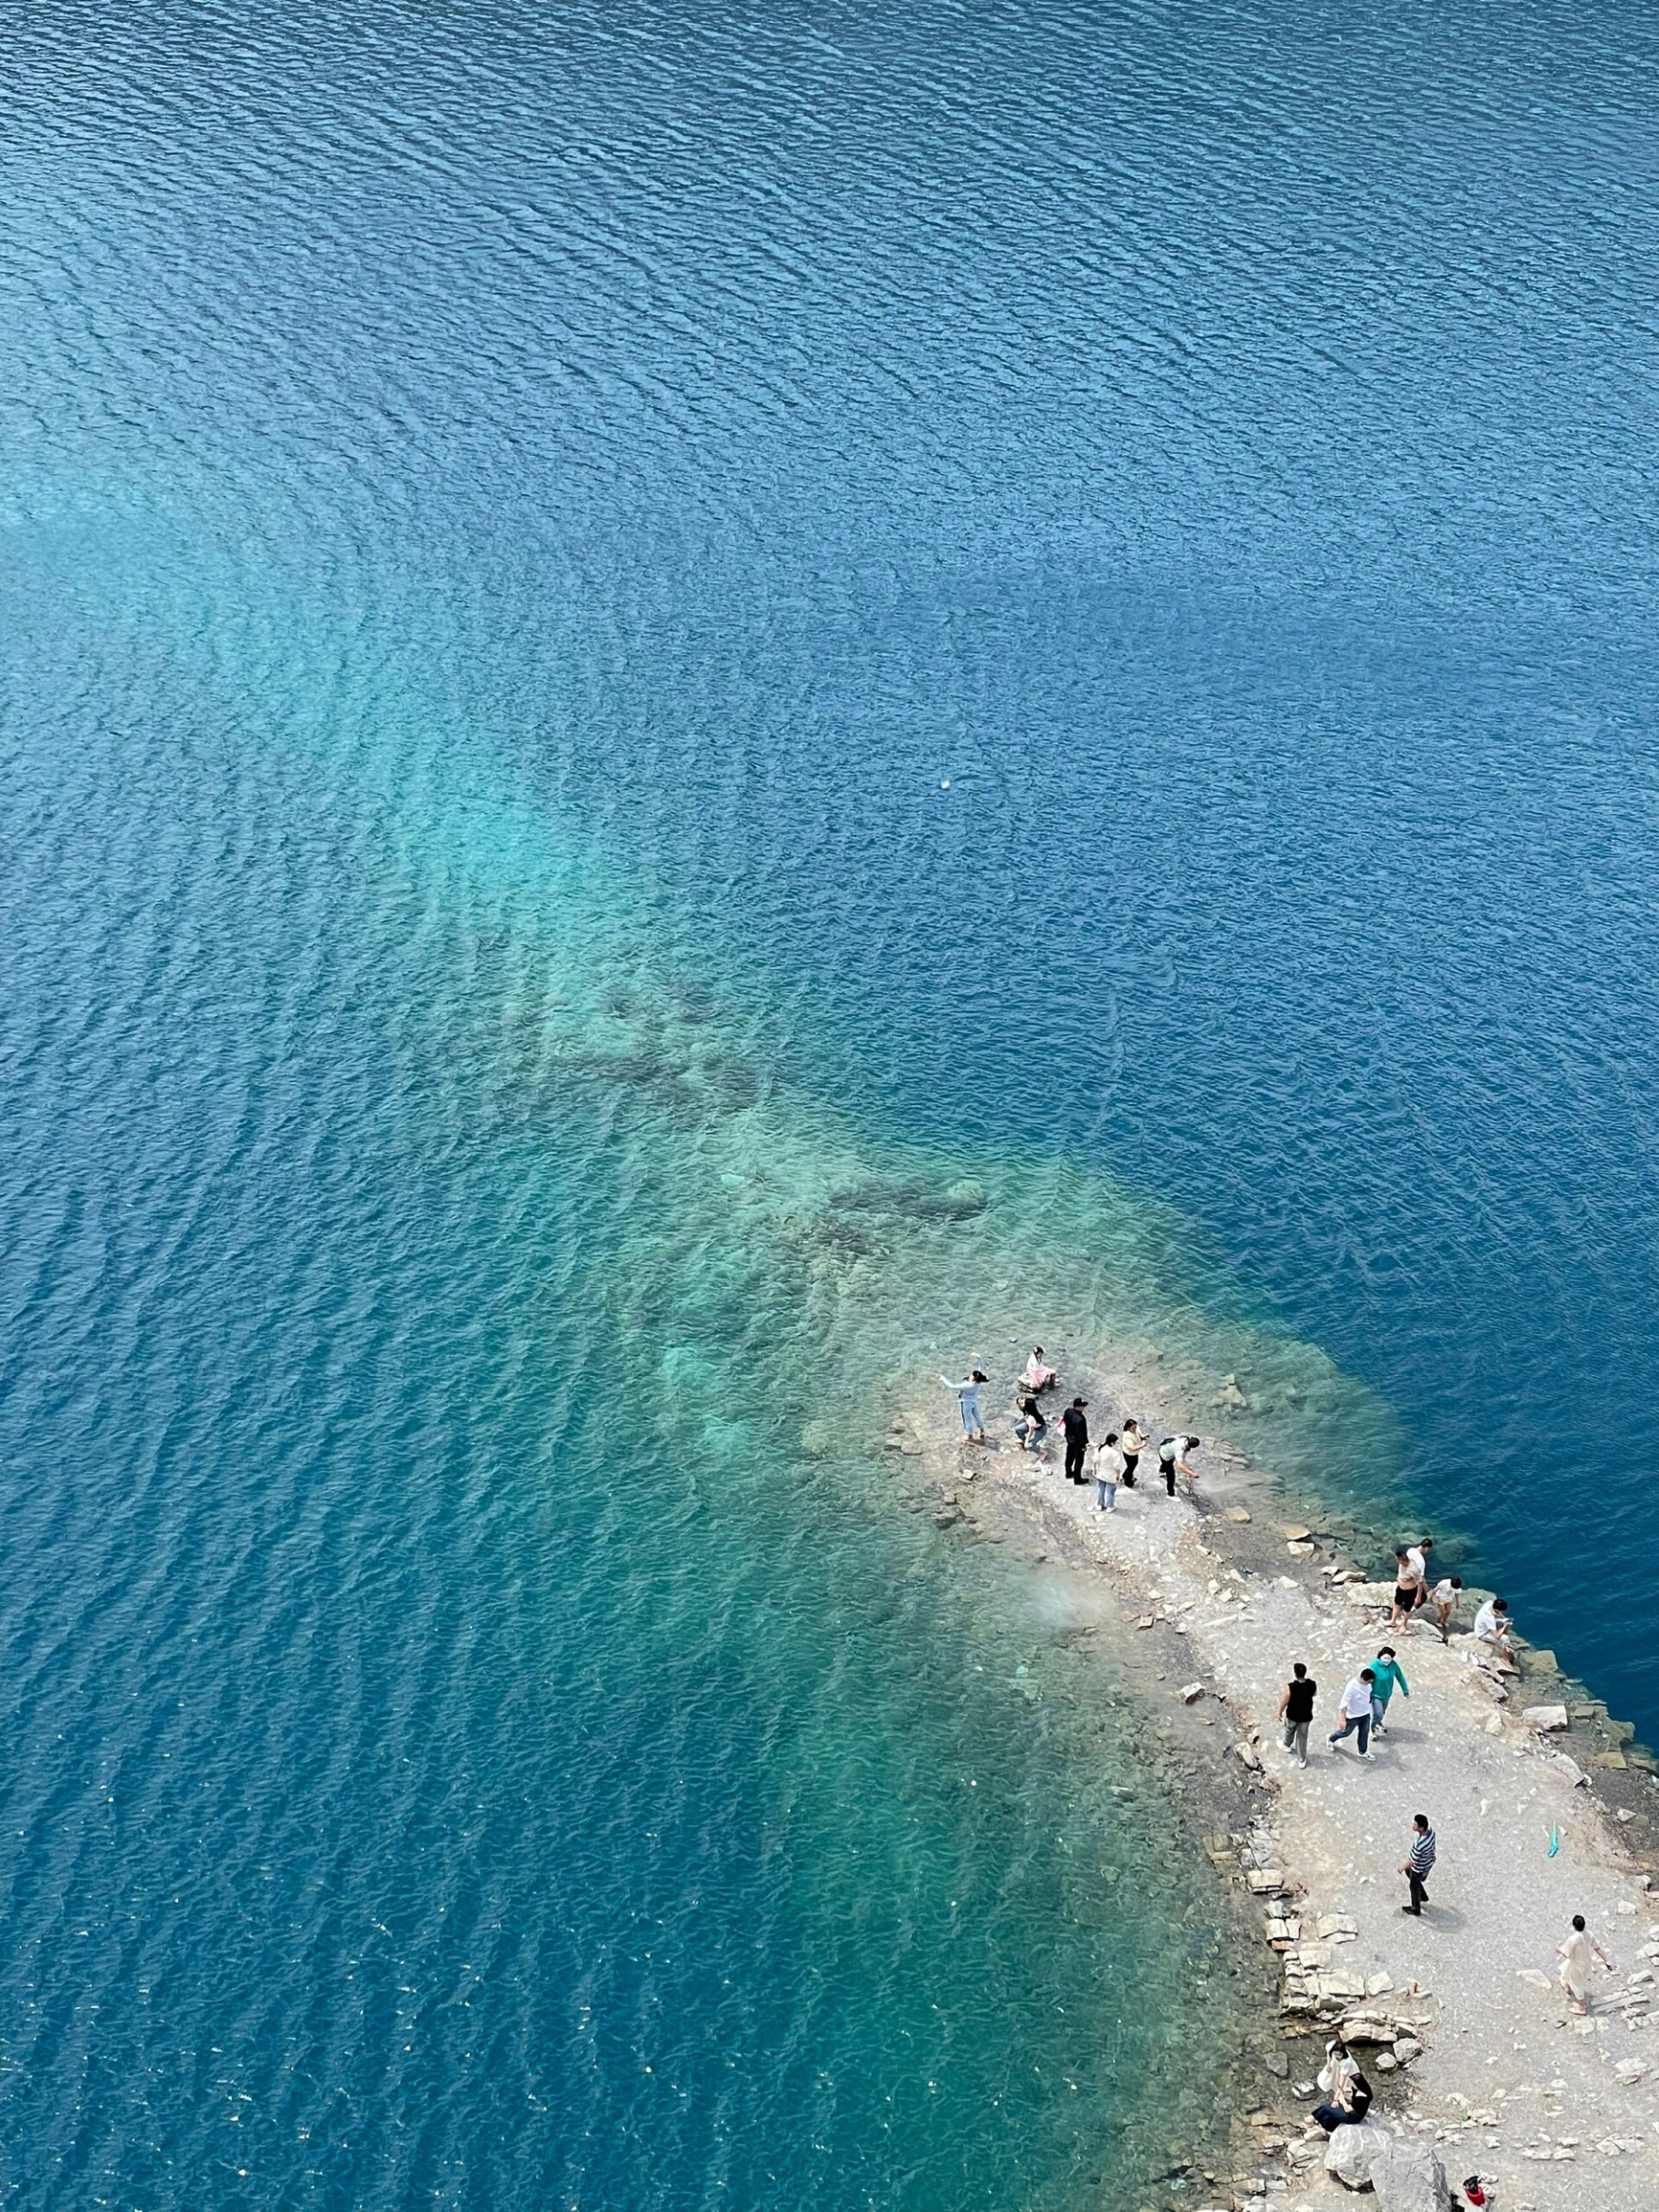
[{"xmin": 885, "ymin": 1354, "xmax": 1659, "ymax": 2212}]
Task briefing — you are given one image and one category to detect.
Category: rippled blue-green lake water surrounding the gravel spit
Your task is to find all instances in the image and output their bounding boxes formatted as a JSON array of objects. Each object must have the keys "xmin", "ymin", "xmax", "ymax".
[{"xmin": 0, "ymin": 0, "xmax": 1659, "ymax": 2212}]
